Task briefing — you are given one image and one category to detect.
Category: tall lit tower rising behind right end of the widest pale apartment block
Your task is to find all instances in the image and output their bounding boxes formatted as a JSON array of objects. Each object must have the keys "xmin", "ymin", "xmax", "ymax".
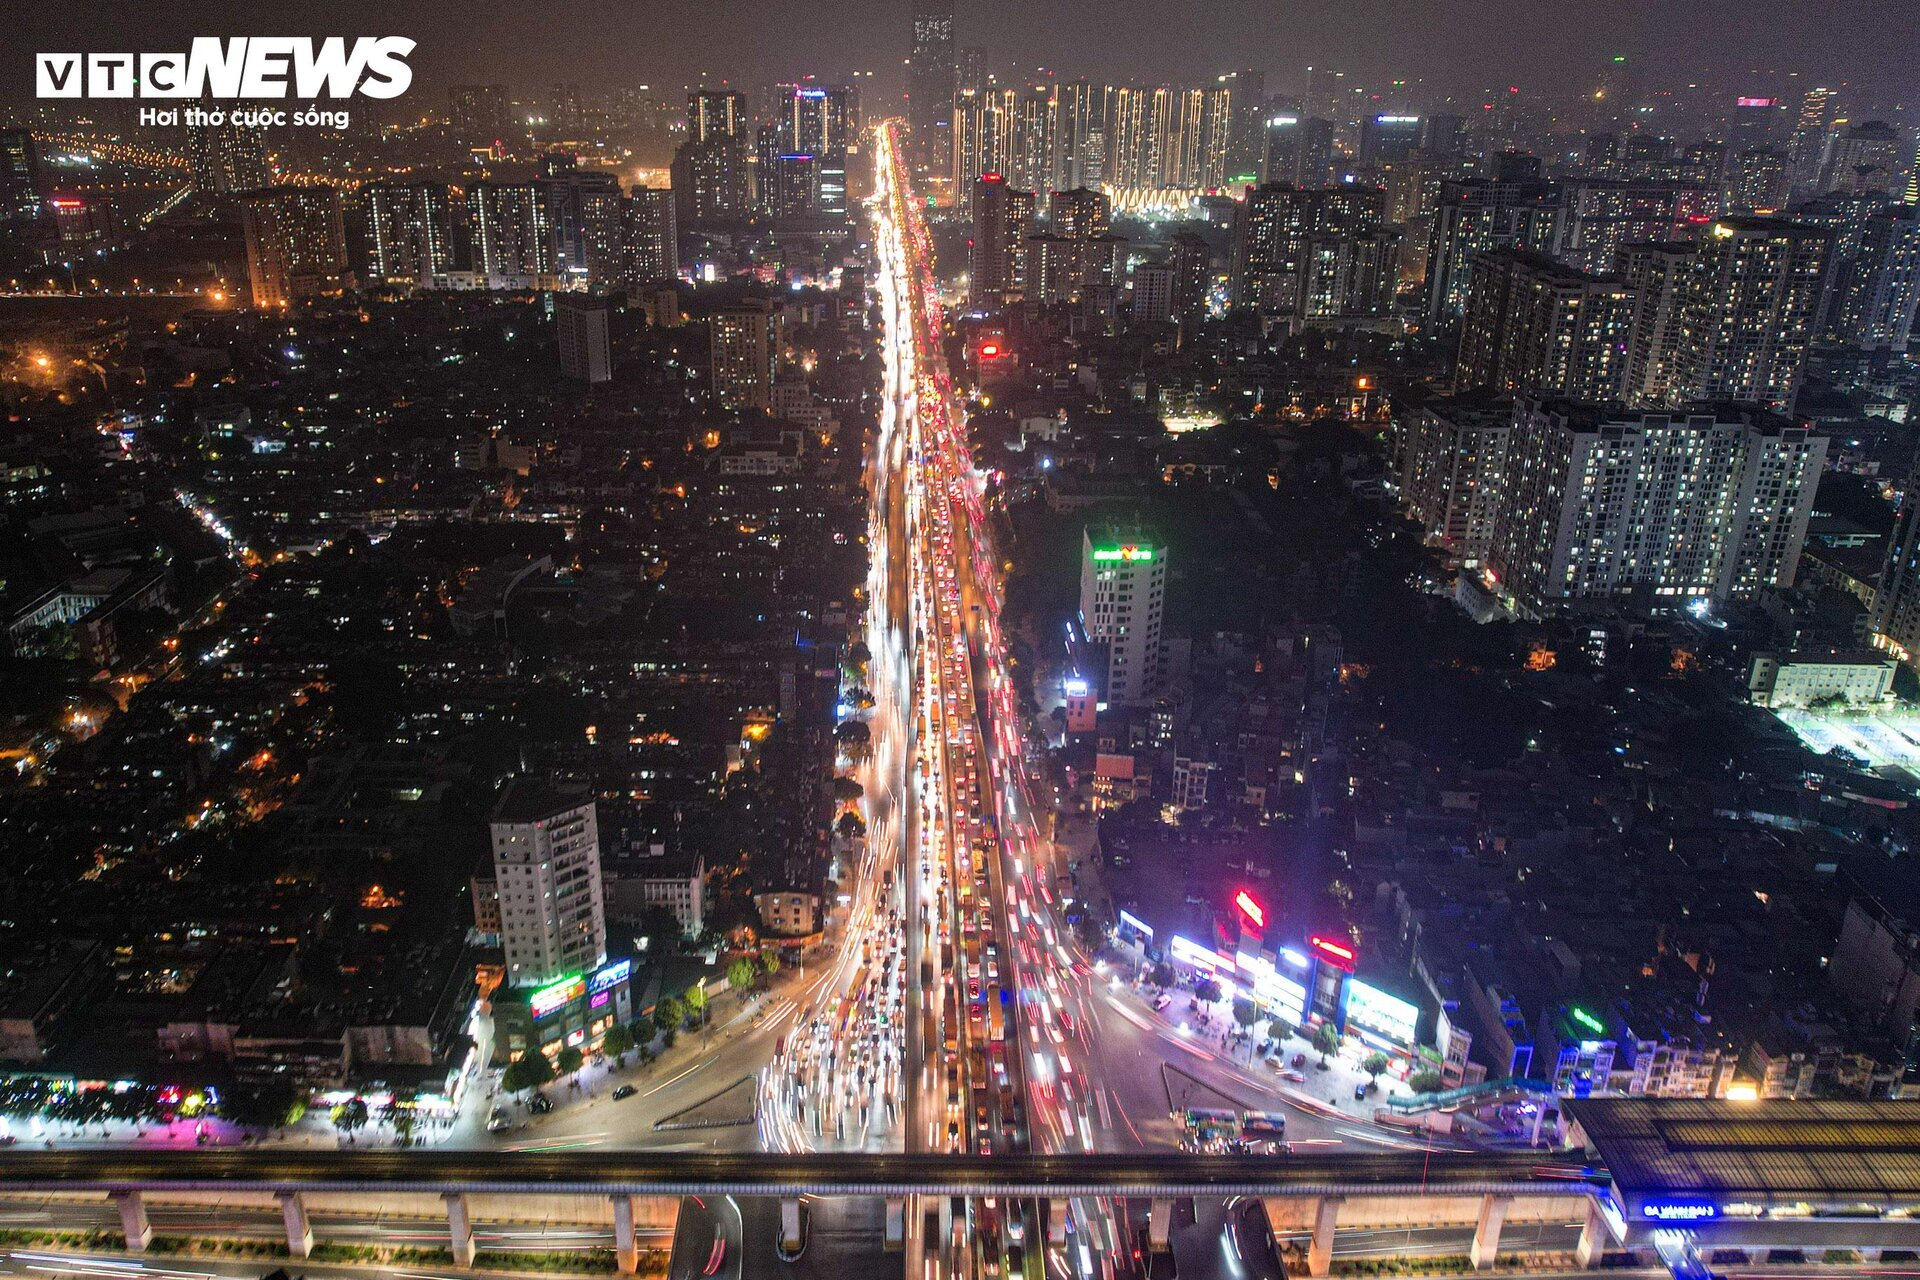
[{"xmin": 1668, "ymin": 217, "xmax": 1834, "ymax": 409}]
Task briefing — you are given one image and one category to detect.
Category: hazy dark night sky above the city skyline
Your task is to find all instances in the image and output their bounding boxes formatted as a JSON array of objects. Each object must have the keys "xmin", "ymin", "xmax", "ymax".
[{"xmin": 0, "ymin": 0, "xmax": 1920, "ymax": 108}]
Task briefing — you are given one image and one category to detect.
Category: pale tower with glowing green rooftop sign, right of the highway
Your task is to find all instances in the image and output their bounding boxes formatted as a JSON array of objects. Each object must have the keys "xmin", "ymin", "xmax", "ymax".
[{"xmin": 1079, "ymin": 528, "xmax": 1167, "ymax": 706}]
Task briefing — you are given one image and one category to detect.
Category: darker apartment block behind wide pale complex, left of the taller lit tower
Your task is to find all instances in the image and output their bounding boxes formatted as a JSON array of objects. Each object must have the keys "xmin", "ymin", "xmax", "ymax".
[{"xmin": 1453, "ymin": 249, "xmax": 1634, "ymax": 399}]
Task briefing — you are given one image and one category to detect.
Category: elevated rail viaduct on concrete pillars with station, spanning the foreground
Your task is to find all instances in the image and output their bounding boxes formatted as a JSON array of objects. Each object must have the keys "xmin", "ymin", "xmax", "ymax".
[{"xmin": 0, "ymin": 1098, "xmax": 1920, "ymax": 1276}]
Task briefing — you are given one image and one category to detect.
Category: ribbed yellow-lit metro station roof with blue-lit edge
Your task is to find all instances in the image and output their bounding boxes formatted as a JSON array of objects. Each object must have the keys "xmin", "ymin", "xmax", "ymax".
[{"xmin": 1561, "ymin": 1098, "xmax": 1920, "ymax": 1211}]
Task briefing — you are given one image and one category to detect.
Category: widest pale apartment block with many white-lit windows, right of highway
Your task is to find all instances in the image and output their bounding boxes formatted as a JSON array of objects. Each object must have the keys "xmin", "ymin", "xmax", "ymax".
[{"xmin": 1488, "ymin": 397, "xmax": 1826, "ymax": 618}]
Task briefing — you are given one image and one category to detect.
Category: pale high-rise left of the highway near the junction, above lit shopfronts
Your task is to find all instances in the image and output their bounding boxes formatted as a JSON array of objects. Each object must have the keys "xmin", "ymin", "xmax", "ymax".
[{"xmin": 490, "ymin": 777, "xmax": 607, "ymax": 988}]
